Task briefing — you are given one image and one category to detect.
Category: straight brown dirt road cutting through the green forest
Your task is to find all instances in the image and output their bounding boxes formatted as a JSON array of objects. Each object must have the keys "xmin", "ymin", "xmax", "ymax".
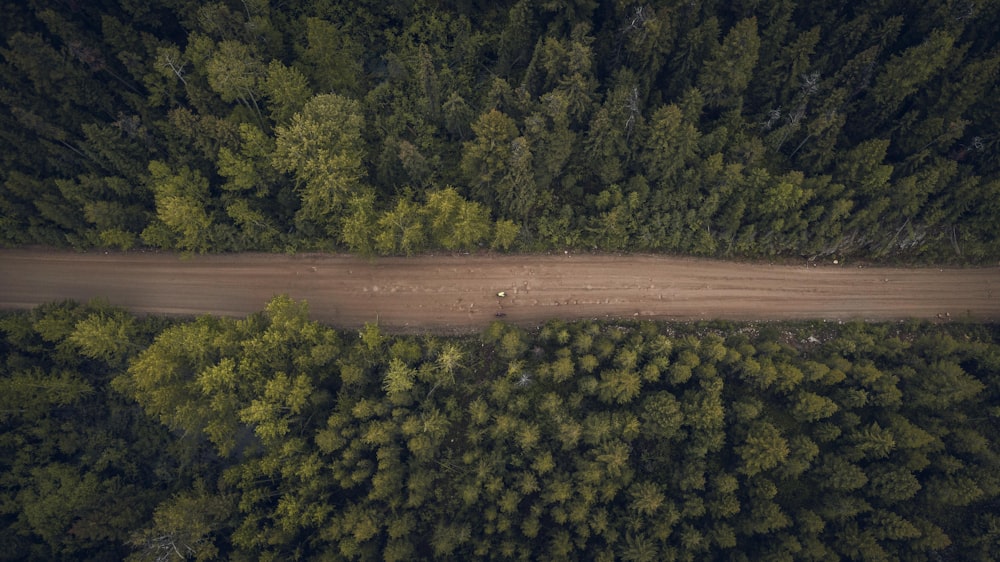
[{"xmin": 0, "ymin": 250, "xmax": 1000, "ymax": 333}]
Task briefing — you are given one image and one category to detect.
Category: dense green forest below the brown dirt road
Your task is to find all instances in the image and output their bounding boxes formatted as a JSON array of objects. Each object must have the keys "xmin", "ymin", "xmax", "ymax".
[{"xmin": 0, "ymin": 296, "xmax": 1000, "ymax": 561}]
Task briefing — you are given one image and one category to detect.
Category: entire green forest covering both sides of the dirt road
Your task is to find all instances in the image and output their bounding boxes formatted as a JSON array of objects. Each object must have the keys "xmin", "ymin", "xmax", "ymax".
[{"xmin": 0, "ymin": 0, "xmax": 1000, "ymax": 562}]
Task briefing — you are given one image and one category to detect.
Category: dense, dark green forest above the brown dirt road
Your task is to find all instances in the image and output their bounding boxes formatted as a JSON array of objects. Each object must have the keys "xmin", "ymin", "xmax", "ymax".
[{"xmin": 0, "ymin": 0, "xmax": 1000, "ymax": 261}]
